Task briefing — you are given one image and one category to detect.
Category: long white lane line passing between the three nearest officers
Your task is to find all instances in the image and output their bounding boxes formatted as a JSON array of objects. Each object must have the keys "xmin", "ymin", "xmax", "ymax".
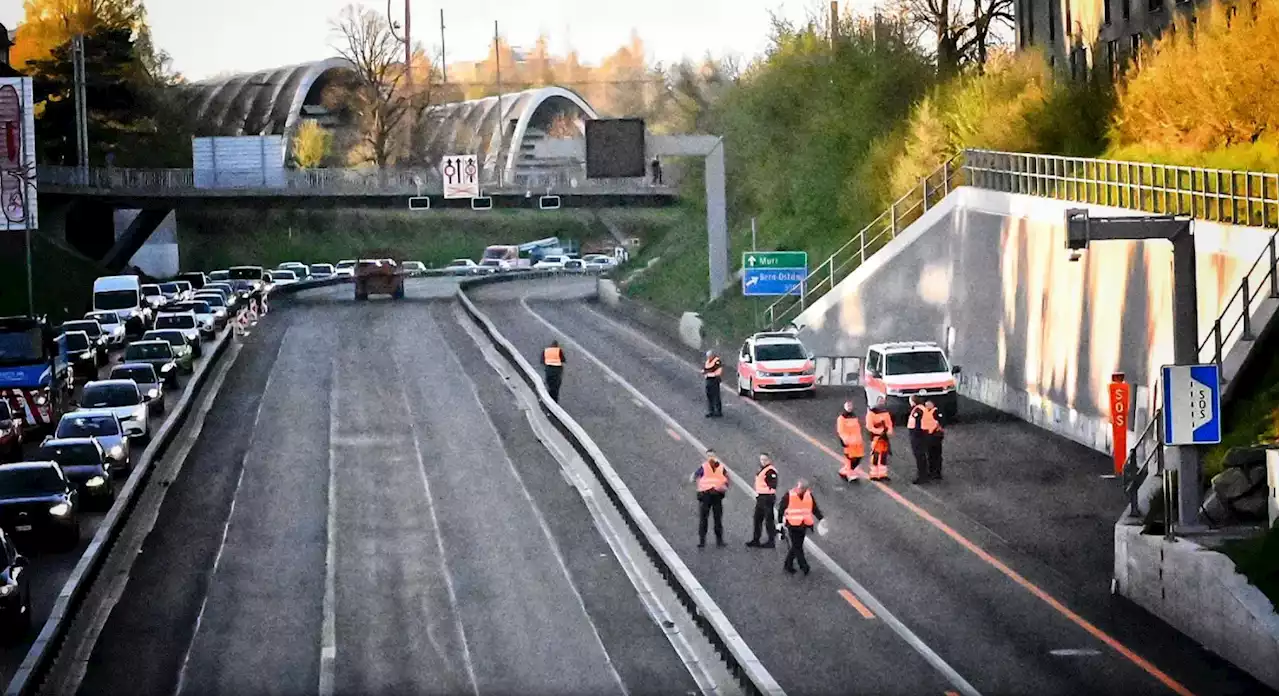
[{"xmin": 520, "ymin": 294, "xmax": 980, "ymax": 696}]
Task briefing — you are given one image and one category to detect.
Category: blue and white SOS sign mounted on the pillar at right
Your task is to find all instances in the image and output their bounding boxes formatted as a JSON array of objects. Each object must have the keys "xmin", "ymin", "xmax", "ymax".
[{"xmin": 1161, "ymin": 365, "xmax": 1222, "ymax": 445}]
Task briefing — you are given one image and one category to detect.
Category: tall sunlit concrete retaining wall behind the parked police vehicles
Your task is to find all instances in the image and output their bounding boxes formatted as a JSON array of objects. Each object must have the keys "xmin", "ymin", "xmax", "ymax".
[{"xmin": 797, "ymin": 187, "xmax": 1270, "ymax": 452}]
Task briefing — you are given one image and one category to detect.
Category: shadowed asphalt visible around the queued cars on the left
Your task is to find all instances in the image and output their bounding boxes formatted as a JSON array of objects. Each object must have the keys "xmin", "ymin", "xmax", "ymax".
[{"xmin": 0, "ymin": 332, "xmax": 217, "ymax": 683}]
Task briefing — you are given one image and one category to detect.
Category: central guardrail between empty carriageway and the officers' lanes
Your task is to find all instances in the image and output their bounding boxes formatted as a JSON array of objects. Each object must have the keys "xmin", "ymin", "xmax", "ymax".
[{"xmin": 458, "ymin": 273, "xmax": 783, "ymax": 695}]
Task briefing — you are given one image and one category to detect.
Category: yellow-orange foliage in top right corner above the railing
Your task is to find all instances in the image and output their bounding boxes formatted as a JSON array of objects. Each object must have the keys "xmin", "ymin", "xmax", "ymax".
[{"xmin": 1111, "ymin": 0, "xmax": 1280, "ymax": 159}]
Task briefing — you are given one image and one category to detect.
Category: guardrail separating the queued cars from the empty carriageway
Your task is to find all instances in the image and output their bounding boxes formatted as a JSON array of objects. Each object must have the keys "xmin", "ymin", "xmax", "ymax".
[{"xmin": 5, "ymin": 279, "xmax": 342, "ymax": 696}]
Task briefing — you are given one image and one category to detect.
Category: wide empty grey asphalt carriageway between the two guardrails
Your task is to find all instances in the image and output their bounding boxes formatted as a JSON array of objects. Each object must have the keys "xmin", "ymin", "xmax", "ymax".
[{"xmin": 81, "ymin": 281, "xmax": 696, "ymax": 695}]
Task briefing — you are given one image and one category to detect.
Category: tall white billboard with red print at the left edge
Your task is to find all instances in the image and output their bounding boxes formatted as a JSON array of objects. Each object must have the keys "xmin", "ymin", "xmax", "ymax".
[{"xmin": 0, "ymin": 77, "xmax": 38, "ymax": 230}]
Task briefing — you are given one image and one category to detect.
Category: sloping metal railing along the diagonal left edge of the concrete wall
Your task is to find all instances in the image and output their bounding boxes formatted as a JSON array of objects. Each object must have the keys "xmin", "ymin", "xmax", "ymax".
[{"xmin": 764, "ymin": 155, "xmax": 964, "ymax": 329}]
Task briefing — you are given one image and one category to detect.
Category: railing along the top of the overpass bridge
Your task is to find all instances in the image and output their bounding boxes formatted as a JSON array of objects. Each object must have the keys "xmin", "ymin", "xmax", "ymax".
[{"xmin": 36, "ymin": 165, "xmax": 678, "ymax": 196}]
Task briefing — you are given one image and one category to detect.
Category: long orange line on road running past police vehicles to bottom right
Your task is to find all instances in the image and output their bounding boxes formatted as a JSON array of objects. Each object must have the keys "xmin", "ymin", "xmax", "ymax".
[{"xmin": 576, "ymin": 299, "xmax": 1194, "ymax": 696}]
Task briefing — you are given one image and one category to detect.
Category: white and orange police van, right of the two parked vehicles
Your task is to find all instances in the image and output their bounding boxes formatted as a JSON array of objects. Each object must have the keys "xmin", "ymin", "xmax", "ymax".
[{"xmin": 863, "ymin": 340, "xmax": 960, "ymax": 421}]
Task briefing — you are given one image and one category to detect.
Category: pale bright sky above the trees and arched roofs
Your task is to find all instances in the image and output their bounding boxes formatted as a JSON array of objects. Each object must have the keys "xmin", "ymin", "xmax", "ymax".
[{"xmin": 0, "ymin": 0, "xmax": 870, "ymax": 79}]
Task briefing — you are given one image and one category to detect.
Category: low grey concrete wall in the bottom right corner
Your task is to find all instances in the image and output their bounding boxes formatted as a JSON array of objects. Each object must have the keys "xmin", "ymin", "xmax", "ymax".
[{"xmin": 1115, "ymin": 525, "xmax": 1280, "ymax": 688}]
